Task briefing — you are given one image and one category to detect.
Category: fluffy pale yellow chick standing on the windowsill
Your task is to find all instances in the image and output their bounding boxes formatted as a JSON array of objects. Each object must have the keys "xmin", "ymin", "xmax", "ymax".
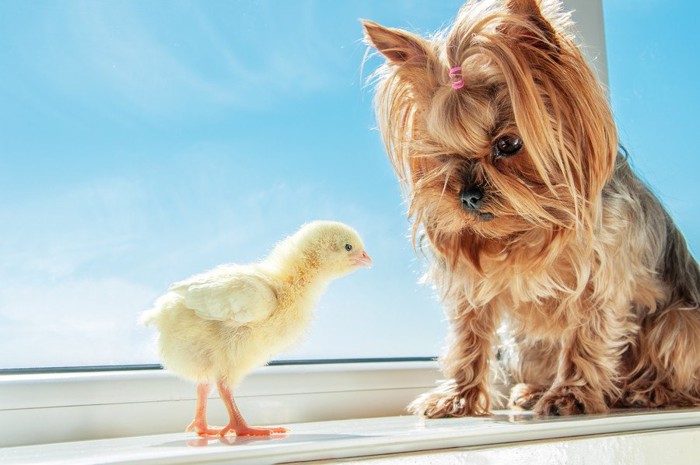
[{"xmin": 141, "ymin": 221, "xmax": 372, "ymax": 436}]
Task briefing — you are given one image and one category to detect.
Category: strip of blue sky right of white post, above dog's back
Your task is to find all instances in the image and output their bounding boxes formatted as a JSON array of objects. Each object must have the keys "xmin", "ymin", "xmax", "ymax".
[{"xmin": 603, "ymin": 0, "xmax": 700, "ymax": 254}]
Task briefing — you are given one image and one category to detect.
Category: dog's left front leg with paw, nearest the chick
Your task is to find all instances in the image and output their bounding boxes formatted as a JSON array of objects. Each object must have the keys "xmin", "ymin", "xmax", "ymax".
[{"xmin": 408, "ymin": 308, "xmax": 499, "ymax": 418}]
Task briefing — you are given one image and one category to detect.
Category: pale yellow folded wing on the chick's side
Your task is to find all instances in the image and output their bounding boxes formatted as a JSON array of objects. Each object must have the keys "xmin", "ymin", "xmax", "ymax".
[{"xmin": 170, "ymin": 269, "xmax": 277, "ymax": 324}]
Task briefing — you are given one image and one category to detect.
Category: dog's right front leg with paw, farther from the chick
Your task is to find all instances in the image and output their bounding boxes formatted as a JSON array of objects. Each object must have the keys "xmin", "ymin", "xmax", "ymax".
[{"xmin": 534, "ymin": 310, "xmax": 629, "ymax": 415}]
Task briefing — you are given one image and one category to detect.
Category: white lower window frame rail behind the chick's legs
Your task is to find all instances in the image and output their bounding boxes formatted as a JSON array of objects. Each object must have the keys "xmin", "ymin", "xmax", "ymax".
[{"xmin": 0, "ymin": 360, "xmax": 440, "ymax": 447}]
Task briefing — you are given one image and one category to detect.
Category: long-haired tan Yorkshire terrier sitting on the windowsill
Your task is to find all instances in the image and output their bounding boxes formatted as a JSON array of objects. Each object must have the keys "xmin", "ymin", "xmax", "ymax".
[{"xmin": 364, "ymin": 0, "xmax": 700, "ymax": 417}]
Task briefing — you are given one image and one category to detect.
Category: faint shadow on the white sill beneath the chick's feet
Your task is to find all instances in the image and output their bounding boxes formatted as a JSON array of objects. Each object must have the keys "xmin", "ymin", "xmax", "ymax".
[{"xmin": 151, "ymin": 433, "xmax": 372, "ymax": 447}]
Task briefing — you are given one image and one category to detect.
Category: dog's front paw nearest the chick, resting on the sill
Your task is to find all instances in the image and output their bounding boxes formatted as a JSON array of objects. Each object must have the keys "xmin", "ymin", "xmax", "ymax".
[{"xmin": 408, "ymin": 385, "xmax": 489, "ymax": 418}]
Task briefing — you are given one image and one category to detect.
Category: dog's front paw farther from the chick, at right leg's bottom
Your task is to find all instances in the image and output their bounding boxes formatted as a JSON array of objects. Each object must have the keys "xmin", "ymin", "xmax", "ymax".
[{"xmin": 535, "ymin": 386, "xmax": 608, "ymax": 416}]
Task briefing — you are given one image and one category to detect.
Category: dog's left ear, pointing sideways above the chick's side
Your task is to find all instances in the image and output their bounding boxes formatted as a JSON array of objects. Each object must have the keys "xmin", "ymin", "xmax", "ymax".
[{"xmin": 362, "ymin": 20, "xmax": 429, "ymax": 67}]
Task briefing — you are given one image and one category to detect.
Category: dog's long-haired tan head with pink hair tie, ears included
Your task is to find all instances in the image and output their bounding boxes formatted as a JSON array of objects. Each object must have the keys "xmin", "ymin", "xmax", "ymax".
[{"xmin": 364, "ymin": 0, "xmax": 617, "ymax": 251}]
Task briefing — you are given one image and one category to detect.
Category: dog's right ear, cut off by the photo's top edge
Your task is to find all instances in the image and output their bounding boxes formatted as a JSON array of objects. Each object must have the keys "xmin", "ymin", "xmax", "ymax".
[{"xmin": 504, "ymin": 0, "xmax": 560, "ymax": 52}]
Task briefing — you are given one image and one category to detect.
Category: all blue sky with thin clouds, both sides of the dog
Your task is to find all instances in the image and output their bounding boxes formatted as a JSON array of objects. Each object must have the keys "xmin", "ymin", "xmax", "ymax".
[{"xmin": 0, "ymin": 0, "xmax": 700, "ymax": 367}]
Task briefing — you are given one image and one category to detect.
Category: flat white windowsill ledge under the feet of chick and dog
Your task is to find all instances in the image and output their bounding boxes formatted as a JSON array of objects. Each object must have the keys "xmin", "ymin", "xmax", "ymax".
[{"xmin": 0, "ymin": 410, "xmax": 700, "ymax": 465}]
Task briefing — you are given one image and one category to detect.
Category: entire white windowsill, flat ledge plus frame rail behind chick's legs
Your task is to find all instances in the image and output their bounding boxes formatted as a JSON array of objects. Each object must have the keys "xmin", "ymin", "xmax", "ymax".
[{"xmin": 5, "ymin": 362, "xmax": 700, "ymax": 465}]
